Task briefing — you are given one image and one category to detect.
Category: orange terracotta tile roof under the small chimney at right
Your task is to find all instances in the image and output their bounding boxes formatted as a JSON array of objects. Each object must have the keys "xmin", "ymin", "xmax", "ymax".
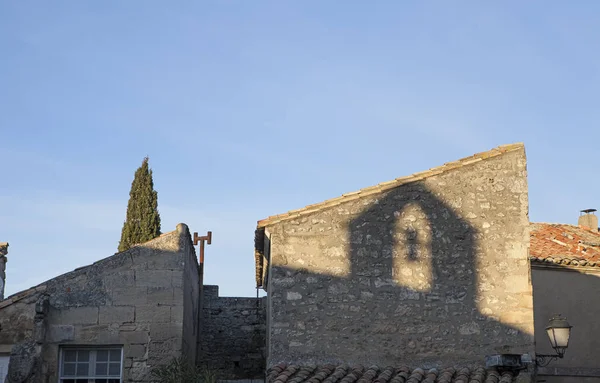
[{"xmin": 529, "ymin": 223, "xmax": 600, "ymax": 267}]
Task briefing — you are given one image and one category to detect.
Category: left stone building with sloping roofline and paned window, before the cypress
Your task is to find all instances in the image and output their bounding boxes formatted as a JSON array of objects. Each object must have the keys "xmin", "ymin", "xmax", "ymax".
[{"xmin": 0, "ymin": 224, "xmax": 200, "ymax": 383}]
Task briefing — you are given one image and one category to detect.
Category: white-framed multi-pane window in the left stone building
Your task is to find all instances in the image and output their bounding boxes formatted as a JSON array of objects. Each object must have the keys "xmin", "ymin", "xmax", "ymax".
[{"xmin": 59, "ymin": 347, "xmax": 123, "ymax": 383}]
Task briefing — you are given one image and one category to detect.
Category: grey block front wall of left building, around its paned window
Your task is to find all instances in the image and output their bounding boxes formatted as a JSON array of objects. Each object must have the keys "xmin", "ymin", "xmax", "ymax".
[{"xmin": 0, "ymin": 224, "xmax": 198, "ymax": 383}]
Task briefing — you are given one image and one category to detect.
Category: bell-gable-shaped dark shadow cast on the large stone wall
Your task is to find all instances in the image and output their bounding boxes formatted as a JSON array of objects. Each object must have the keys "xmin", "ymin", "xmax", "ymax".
[{"xmin": 268, "ymin": 183, "xmax": 533, "ymax": 367}]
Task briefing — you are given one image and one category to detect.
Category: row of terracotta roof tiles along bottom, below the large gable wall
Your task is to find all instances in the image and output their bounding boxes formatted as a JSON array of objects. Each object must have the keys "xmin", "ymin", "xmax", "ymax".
[{"xmin": 267, "ymin": 364, "xmax": 515, "ymax": 383}]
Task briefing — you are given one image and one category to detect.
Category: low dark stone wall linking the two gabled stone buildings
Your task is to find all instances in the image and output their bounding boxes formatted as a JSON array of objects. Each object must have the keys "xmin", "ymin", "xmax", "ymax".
[{"xmin": 198, "ymin": 285, "xmax": 266, "ymax": 380}]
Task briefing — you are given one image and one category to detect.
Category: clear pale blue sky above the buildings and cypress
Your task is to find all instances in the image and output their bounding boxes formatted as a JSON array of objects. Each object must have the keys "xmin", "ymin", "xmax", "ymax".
[{"xmin": 0, "ymin": 0, "xmax": 600, "ymax": 296}]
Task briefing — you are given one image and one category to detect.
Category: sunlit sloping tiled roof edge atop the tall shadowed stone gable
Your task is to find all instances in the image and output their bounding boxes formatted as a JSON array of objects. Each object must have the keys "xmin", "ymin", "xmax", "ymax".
[{"xmin": 257, "ymin": 142, "xmax": 525, "ymax": 227}]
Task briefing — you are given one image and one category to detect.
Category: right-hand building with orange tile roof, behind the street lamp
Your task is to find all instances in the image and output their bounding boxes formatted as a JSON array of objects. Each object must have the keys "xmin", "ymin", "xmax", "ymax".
[{"xmin": 530, "ymin": 213, "xmax": 600, "ymax": 383}]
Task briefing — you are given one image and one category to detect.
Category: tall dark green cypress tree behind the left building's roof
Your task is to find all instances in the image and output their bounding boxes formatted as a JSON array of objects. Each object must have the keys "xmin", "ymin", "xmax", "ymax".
[{"xmin": 119, "ymin": 157, "xmax": 160, "ymax": 251}]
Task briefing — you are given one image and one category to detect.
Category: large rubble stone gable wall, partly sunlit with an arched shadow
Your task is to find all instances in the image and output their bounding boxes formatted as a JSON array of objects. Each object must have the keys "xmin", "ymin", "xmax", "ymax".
[{"xmin": 266, "ymin": 147, "xmax": 534, "ymax": 366}]
